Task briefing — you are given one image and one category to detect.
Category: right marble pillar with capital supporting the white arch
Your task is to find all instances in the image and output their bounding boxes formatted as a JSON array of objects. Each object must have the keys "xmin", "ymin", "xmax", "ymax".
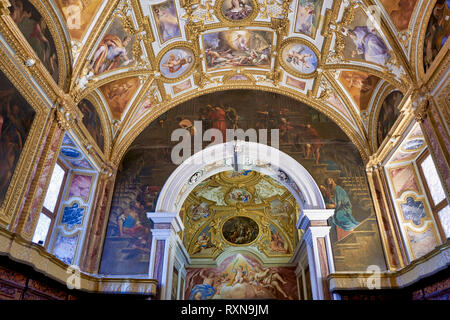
[{"xmin": 297, "ymin": 209, "xmax": 334, "ymax": 300}]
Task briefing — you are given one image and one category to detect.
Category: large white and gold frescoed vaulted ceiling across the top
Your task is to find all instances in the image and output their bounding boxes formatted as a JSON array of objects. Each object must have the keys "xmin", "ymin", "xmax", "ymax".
[{"xmin": 4, "ymin": 0, "xmax": 440, "ymax": 168}]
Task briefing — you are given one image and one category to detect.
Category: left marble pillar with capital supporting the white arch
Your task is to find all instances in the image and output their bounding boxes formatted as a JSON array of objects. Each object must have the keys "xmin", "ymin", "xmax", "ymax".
[{"xmin": 147, "ymin": 212, "xmax": 183, "ymax": 300}]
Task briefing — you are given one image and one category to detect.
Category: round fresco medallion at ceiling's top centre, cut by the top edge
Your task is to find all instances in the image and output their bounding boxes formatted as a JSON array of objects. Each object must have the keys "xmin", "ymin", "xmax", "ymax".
[{"xmin": 217, "ymin": 0, "xmax": 258, "ymax": 21}]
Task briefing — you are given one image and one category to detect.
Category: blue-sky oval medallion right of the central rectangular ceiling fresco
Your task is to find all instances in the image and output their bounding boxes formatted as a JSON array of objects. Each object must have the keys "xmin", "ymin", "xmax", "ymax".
[{"xmin": 280, "ymin": 41, "xmax": 318, "ymax": 77}]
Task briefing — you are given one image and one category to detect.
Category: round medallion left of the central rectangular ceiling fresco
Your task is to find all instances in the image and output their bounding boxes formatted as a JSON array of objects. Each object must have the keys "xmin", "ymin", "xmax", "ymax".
[{"xmin": 159, "ymin": 47, "xmax": 194, "ymax": 79}]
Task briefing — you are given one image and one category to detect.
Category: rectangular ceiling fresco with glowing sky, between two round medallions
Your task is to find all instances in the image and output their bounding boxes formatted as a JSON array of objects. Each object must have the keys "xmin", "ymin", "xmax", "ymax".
[{"xmin": 203, "ymin": 30, "xmax": 273, "ymax": 69}]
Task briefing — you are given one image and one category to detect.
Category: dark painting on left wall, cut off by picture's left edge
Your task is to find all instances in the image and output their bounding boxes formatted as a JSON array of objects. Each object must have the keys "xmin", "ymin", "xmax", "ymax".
[{"xmin": 0, "ymin": 72, "xmax": 35, "ymax": 204}]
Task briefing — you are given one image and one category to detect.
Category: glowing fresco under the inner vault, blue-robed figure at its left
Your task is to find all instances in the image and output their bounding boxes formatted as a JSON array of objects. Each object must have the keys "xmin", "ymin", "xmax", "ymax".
[{"xmin": 185, "ymin": 254, "xmax": 298, "ymax": 300}]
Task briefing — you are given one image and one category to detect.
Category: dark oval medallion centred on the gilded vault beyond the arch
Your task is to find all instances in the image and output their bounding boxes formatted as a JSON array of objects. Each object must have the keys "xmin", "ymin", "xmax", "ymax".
[{"xmin": 222, "ymin": 217, "xmax": 259, "ymax": 245}]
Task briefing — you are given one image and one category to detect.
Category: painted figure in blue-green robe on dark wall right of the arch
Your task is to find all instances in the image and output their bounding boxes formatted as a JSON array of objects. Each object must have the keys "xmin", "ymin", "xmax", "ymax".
[{"xmin": 321, "ymin": 178, "xmax": 359, "ymax": 240}]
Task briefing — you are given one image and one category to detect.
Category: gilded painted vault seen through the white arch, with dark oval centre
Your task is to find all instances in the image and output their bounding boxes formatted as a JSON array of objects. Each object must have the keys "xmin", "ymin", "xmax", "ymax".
[{"xmin": 181, "ymin": 170, "xmax": 298, "ymax": 264}]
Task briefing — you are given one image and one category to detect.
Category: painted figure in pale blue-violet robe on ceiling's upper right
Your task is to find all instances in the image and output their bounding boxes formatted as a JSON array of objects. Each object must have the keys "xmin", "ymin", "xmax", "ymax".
[{"xmin": 343, "ymin": 26, "xmax": 391, "ymax": 66}]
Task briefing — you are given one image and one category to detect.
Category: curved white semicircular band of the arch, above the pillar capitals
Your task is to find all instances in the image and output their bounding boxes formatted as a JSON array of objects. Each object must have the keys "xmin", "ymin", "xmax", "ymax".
[{"xmin": 156, "ymin": 141, "xmax": 325, "ymax": 213}]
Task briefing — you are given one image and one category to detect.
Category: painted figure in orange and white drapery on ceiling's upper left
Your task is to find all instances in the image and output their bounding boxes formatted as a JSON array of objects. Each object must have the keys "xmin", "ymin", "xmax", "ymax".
[{"xmin": 90, "ymin": 34, "xmax": 134, "ymax": 75}]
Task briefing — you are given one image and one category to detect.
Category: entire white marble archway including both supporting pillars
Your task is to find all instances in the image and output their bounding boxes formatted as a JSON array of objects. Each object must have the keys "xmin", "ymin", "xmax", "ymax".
[{"xmin": 147, "ymin": 141, "xmax": 334, "ymax": 299}]
